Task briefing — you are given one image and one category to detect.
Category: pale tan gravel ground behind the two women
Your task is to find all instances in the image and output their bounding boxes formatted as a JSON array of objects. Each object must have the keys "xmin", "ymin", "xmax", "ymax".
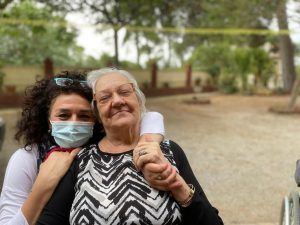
[{"xmin": 0, "ymin": 94, "xmax": 300, "ymax": 225}]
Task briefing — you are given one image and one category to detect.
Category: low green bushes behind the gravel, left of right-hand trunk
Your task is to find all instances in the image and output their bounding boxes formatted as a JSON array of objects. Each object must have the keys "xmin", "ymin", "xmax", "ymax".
[{"xmin": 190, "ymin": 43, "xmax": 275, "ymax": 93}]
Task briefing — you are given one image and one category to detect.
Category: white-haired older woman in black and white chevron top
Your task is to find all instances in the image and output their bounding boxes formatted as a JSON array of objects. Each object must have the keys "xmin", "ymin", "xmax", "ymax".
[{"xmin": 38, "ymin": 69, "xmax": 223, "ymax": 225}]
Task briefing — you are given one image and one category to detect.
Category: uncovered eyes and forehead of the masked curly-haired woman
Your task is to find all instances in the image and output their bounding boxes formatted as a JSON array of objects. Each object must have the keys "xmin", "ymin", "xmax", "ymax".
[{"xmin": 49, "ymin": 93, "xmax": 94, "ymax": 122}]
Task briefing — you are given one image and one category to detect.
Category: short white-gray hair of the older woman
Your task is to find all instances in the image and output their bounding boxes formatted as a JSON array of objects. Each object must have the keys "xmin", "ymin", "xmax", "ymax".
[{"xmin": 87, "ymin": 68, "xmax": 147, "ymax": 117}]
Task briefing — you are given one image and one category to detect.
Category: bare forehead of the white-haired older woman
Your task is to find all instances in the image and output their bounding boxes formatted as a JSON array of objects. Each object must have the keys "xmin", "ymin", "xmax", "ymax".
[{"xmin": 96, "ymin": 73, "xmax": 130, "ymax": 91}]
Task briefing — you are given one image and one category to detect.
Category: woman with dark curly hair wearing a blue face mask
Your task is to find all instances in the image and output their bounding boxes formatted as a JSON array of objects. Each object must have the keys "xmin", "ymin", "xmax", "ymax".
[{"xmin": 0, "ymin": 71, "xmax": 164, "ymax": 225}]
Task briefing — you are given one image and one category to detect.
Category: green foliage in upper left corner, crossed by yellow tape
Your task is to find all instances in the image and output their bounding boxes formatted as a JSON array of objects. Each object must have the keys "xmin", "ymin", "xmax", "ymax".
[{"xmin": 0, "ymin": 0, "xmax": 83, "ymax": 66}]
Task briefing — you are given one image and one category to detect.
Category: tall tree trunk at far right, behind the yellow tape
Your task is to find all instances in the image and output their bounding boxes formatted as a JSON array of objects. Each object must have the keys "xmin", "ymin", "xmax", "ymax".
[{"xmin": 276, "ymin": 0, "xmax": 296, "ymax": 92}]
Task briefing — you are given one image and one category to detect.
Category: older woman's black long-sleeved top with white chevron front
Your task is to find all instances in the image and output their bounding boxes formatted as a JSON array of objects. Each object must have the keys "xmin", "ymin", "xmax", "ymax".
[{"xmin": 37, "ymin": 141, "xmax": 223, "ymax": 225}]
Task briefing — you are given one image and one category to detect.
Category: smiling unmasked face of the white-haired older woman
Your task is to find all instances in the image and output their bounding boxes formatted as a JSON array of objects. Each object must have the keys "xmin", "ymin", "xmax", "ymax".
[{"xmin": 94, "ymin": 73, "xmax": 141, "ymax": 130}]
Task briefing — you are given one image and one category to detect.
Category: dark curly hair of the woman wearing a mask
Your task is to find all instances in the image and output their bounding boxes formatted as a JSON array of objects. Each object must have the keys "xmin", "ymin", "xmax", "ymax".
[{"xmin": 15, "ymin": 71, "xmax": 102, "ymax": 148}]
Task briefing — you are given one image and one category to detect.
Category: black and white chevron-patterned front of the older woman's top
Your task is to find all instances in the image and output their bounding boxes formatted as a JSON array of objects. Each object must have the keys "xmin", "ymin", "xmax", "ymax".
[{"xmin": 70, "ymin": 142, "xmax": 181, "ymax": 225}]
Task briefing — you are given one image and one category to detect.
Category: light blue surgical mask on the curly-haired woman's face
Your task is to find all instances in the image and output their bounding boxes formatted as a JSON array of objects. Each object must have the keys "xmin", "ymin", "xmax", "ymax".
[{"xmin": 50, "ymin": 121, "xmax": 94, "ymax": 148}]
